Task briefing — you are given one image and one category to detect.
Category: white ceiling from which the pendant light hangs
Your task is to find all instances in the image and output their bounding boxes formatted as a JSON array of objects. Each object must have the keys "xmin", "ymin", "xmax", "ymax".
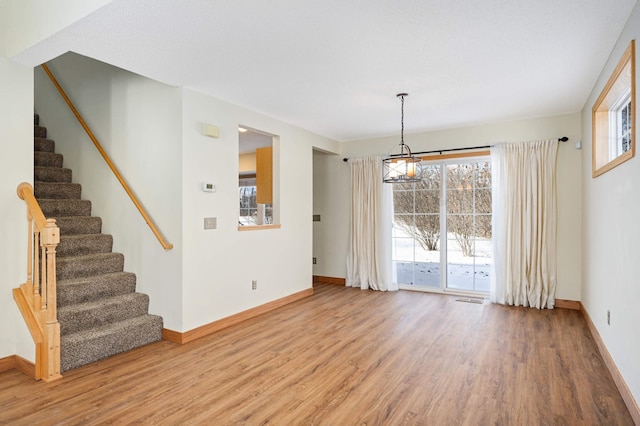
[{"xmin": 16, "ymin": 0, "xmax": 636, "ymax": 141}]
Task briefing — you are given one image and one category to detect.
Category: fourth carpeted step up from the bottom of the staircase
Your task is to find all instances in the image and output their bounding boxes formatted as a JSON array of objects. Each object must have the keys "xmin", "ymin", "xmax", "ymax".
[{"xmin": 56, "ymin": 253, "xmax": 124, "ymax": 280}]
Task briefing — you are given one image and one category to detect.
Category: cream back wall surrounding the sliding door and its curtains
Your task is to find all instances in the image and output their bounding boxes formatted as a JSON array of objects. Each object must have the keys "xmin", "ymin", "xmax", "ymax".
[{"xmin": 314, "ymin": 114, "xmax": 582, "ymax": 300}]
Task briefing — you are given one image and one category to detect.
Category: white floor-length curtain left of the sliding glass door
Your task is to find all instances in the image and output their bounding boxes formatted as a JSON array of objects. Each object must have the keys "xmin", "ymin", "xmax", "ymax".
[{"xmin": 346, "ymin": 156, "xmax": 398, "ymax": 291}]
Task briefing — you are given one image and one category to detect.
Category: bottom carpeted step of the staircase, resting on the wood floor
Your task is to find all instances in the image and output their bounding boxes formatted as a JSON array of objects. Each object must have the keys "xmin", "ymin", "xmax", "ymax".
[{"xmin": 60, "ymin": 314, "xmax": 162, "ymax": 372}]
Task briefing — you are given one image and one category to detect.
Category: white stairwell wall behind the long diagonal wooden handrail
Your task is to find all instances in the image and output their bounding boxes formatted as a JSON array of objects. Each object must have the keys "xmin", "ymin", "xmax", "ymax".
[{"xmin": 35, "ymin": 53, "xmax": 183, "ymax": 329}]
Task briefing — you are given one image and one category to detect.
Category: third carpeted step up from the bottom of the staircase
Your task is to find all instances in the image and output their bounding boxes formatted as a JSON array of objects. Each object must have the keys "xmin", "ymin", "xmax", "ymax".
[{"xmin": 57, "ymin": 272, "xmax": 136, "ymax": 308}]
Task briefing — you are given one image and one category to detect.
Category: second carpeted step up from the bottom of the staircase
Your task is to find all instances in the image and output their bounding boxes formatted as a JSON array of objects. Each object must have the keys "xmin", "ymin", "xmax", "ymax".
[{"xmin": 58, "ymin": 293, "xmax": 149, "ymax": 336}]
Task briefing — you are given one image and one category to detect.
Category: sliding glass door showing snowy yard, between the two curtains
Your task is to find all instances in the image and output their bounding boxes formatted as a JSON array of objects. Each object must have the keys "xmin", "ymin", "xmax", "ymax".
[{"xmin": 393, "ymin": 158, "xmax": 492, "ymax": 292}]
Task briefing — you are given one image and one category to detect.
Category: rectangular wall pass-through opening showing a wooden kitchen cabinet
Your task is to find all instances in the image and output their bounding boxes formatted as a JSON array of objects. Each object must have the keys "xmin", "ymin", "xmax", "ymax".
[{"xmin": 238, "ymin": 126, "xmax": 278, "ymax": 230}]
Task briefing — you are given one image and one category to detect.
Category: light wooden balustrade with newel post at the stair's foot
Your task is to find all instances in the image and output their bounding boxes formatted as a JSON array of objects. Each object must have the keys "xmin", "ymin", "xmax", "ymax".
[{"xmin": 13, "ymin": 182, "xmax": 62, "ymax": 381}]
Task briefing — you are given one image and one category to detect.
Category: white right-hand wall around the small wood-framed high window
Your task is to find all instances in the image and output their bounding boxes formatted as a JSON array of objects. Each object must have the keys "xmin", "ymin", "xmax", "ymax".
[{"xmin": 582, "ymin": 4, "xmax": 640, "ymax": 402}]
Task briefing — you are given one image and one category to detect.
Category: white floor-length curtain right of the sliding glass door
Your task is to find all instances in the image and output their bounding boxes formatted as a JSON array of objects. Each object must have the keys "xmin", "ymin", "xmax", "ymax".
[{"xmin": 490, "ymin": 140, "xmax": 558, "ymax": 309}]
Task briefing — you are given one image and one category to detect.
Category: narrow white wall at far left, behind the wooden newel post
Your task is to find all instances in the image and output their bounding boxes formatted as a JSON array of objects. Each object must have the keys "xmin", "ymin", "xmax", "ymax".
[{"xmin": 0, "ymin": 57, "xmax": 35, "ymax": 360}]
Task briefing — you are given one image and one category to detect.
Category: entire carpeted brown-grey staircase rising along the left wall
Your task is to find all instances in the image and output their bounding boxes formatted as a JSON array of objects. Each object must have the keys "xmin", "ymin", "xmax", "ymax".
[{"xmin": 34, "ymin": 115, "xmax": 162, "ymax": 371}]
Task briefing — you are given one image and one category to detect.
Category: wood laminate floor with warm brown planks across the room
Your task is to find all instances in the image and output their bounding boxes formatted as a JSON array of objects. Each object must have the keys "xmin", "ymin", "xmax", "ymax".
[{"xmin": 0, "ymin": 285, "xmax": 633, "ymax": 426}]
